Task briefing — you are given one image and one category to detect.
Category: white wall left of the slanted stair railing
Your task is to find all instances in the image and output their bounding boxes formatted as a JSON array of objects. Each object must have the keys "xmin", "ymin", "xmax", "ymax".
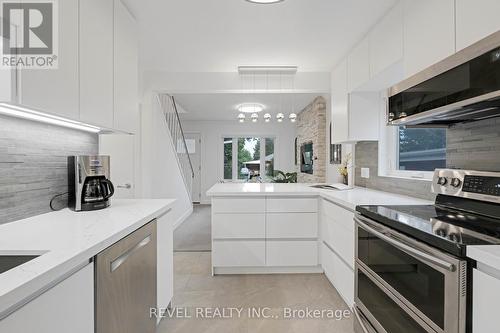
[{"xmin": 141, "ymin": 96, "xmax": 193, "ymax": 228}]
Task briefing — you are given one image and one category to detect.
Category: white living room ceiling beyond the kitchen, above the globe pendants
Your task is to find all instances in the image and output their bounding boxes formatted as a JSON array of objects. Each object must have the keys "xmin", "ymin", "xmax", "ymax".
[{"xmin": 174, "ymin": 93, "xmax": 327, "ymax": 122}]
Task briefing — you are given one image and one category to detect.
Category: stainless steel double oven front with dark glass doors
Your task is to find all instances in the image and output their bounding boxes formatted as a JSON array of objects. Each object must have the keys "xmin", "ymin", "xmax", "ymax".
[{"xmin": 355, "ymin": 214, "xmax": 467, "ymax": 333}]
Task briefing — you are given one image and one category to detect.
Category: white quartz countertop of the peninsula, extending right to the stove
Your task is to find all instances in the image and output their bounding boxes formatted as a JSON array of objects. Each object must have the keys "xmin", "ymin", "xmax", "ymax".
[{"xmin": 207, "ymin": 183, "xmax": 433, "ymax": 211}]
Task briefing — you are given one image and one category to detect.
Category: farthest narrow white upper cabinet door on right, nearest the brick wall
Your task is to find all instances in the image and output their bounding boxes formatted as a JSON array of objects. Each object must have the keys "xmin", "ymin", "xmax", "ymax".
[{"xmin": 331, "ymin": 60, "xmax": 349, "ymax": 143}]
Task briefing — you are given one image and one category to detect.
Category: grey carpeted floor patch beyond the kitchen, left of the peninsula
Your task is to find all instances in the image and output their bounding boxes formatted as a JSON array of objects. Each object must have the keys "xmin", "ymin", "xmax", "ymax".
[{"xmin": 174, "ymin": 205, "xmax": 212, "ymax": 252}]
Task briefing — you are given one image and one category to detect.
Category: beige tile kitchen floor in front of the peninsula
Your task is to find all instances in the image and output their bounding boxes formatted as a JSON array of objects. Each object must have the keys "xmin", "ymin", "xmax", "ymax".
[{"xmin": 157, "ymin": 252, "xmax": 353, "ymax": 333}]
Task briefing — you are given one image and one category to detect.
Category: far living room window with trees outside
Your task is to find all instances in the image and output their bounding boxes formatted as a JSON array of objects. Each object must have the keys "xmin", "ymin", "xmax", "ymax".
[{"xmin": 223, "ymin": 136, "xmax": 275, "ymax": 181}]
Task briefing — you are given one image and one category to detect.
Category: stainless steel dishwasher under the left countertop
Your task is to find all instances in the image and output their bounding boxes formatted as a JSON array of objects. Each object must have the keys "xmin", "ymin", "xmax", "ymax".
[{"xmin": 95, "ymin": 220, "xmax": 156, "ymax": 333}]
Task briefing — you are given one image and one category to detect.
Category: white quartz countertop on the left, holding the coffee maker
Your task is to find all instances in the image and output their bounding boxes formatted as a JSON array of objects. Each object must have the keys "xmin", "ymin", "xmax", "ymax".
[{"xmin": 0, "ymin": 199, "xmax": 175, "ymax": 318}]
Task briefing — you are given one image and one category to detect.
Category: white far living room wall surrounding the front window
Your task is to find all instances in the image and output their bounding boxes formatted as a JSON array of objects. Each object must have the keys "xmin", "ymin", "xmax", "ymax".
[{"xmin": 183, "ymin": 120, "xmax": 296, "ymax": 203}]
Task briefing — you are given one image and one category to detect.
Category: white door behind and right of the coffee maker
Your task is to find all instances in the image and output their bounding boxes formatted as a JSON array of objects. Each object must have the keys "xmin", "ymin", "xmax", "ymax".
[{"xmin": 99, "ymin": 134, "xmax": 135, "ymax": 199}]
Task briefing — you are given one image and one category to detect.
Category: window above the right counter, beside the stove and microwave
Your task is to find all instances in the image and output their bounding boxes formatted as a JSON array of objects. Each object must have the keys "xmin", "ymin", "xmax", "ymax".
[{"xmin": 398, "ymin": 127, "xmax": 446, "ymax": 171}]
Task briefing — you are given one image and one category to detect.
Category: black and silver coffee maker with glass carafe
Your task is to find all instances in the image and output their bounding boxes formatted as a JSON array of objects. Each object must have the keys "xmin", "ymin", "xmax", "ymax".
[{"xmin": 68, "ymin": 155, "xmax": 115, "ymax": 211}]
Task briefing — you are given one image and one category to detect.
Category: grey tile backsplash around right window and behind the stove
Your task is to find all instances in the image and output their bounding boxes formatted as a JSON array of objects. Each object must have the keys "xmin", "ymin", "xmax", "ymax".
[{"xmin": 355, "ymin": 118, "xmax": 500, "ymax": 200}]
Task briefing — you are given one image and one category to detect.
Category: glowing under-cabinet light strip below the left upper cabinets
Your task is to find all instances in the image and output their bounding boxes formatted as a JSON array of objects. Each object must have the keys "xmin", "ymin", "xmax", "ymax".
[{"xmin": 0, "ymin": 103, "xmax": 101, "ymax": 133}]
